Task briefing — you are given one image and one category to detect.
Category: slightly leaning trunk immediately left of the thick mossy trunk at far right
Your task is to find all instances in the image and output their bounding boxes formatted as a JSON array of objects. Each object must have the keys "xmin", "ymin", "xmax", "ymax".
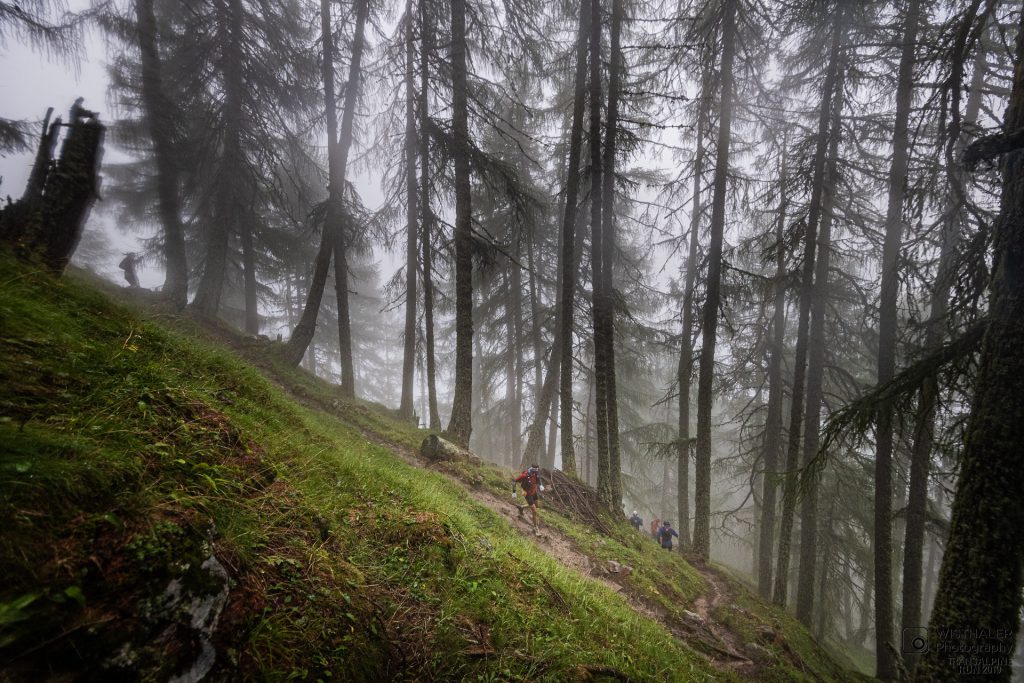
[{"xmin": 900, "ymin": 25, "xmax": 986, "ymax": 672}]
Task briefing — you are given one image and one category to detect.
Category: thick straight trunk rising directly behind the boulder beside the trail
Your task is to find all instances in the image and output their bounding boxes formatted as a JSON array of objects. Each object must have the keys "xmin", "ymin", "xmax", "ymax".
[{"xmin": 447, "ymin": 0, "xmax": 473, "ymax": 445}]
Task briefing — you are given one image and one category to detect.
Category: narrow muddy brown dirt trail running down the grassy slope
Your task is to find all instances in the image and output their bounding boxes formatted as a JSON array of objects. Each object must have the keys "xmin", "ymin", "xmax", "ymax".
[{"xmin": 364, "ymin": 430, "xmax": 759, "ymax": 678}]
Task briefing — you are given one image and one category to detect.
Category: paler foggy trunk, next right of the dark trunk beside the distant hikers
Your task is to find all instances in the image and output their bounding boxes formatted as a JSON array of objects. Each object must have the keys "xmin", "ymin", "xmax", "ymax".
[{"xmin": 757, "ymin": 148, "xmax": 788, "ymax": 599}]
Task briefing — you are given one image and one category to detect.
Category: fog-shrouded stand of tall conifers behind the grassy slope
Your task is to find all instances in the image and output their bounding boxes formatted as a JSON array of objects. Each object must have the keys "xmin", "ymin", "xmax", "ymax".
[{"xmin": 0, "ymin": 0, "xmax": 1024, "ymax": 680}]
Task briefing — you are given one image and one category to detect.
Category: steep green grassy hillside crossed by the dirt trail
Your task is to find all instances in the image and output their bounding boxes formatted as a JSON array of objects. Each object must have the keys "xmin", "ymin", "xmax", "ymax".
[{"xmin": 0, "ymin": 260, "xmax": 864, "ymax": 681}]
